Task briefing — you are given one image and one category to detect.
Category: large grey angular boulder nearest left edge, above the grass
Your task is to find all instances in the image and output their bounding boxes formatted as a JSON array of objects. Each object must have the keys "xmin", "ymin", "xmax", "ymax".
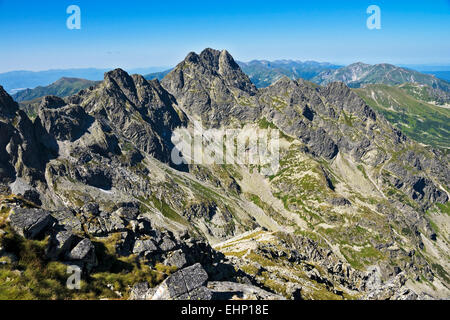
[{"xmin": 9, "ymin": 208, "xmax": 54, "ymax": 239}]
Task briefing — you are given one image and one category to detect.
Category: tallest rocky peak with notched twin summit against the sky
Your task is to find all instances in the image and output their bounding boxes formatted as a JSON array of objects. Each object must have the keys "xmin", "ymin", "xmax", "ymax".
[{"xmin": 161, "ymin": 49, "xmax": 258, "ymax": 125}]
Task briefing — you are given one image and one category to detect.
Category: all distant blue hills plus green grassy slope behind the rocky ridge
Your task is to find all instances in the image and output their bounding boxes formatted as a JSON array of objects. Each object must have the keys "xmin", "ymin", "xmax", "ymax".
[{"xmin": 8, "ymin": 60, "xmax": 450, "ymax": 149}]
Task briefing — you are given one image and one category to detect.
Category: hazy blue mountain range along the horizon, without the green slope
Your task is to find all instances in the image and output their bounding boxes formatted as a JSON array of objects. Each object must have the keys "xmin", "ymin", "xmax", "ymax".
[{"xmin": 4, "ymin": 60, "xmax": 450, "ymax": 94}]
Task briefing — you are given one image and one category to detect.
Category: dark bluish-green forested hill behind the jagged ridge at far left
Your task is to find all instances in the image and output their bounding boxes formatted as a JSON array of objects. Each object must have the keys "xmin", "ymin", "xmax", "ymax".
[{"xmin": 12, "ymin": 78, "xmax": 98, "ymax": 102}]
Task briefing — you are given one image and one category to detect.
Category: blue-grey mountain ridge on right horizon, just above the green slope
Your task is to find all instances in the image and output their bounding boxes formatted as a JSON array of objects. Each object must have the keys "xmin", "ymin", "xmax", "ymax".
[{"xmin": 312, "ymin": 62, "xmax": 450, "ymax": 92}]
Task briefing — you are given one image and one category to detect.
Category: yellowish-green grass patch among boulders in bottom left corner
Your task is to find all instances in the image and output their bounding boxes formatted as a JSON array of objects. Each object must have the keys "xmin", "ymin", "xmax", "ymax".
[{"xmin": 0, "ymin": 228, "xmax": 175, "ymax": 300}]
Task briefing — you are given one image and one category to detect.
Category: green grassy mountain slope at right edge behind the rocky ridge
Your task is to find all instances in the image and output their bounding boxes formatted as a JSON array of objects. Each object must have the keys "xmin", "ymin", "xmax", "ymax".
[{"xmin": 356, "ymin": 84, "xmax": 450, "ymax": 149}]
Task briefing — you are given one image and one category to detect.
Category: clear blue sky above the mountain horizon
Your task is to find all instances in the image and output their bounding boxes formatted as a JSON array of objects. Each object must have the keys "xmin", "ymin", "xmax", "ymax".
[{"xmin": 0, "ymin": 0, "xmax": 450, "ymax": 72}]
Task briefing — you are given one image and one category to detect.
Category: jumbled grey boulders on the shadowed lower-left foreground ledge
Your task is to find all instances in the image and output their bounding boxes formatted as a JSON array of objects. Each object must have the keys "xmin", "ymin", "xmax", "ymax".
[{"xmin": 0, "ymin": 199, "xmax": 284, "ymax": 300}]
